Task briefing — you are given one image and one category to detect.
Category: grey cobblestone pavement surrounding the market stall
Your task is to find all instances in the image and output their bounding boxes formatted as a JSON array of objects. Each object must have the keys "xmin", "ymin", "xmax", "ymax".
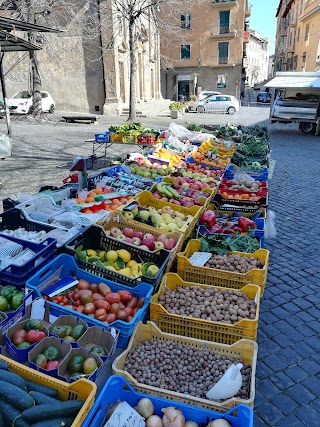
[{"xmin": 0, "ymin": 107, "xmax": 320, "ymax": 427}]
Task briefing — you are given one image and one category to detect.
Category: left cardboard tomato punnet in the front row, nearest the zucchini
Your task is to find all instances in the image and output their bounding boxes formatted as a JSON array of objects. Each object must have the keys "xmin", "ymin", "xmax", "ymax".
[{"xmin": 28, "ymin": 337, "xmax": 71, "ymax": 378}]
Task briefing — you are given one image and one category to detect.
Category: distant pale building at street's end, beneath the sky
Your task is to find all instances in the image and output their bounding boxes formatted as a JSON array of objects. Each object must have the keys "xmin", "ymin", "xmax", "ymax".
[{"xmin": 246, "ymin": 30, "xmax": 269, "ymax": 87}]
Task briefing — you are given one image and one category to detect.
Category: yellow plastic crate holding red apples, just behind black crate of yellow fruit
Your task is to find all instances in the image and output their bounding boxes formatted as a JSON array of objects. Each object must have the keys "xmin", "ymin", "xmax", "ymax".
[{"xmin": 98, "ymin": 211, "xmax": 184, "ymax": 271}]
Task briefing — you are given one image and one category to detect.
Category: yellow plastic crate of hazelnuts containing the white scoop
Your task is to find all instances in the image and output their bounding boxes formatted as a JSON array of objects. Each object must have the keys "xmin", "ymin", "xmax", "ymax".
[{"xmin": 112, "ymin": 322, "xmax": 258, "ymax": 412}]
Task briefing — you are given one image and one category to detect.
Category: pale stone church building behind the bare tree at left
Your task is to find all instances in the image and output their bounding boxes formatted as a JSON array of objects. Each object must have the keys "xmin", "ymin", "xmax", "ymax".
[{"xmin": 2, "ymin": 0, "xmax": 161, "ymax": 114}]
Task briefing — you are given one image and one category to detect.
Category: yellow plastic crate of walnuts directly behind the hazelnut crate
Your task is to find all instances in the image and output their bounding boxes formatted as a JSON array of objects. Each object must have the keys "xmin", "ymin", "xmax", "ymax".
[{"xmin": 150, "ymin": 273, "xmax": 261, "ymax": 344}]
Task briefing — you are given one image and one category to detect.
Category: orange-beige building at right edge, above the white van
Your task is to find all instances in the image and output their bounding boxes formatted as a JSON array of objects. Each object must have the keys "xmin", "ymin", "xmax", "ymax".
[{"xmin": 274, "ymin": 0, "xmax": 320, "ymax": 71}]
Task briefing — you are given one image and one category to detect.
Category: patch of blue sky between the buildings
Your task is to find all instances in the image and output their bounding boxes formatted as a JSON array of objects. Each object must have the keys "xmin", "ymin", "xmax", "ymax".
[{"xmin": 249, "ymin": 0, "xmax": 280, "ymax": 54}]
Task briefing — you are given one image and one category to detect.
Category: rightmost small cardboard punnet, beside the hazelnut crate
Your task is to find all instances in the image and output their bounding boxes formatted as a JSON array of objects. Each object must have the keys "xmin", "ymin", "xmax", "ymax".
[{"xmin": 78, "ymin": 326, "xmax": 120, "ymax": 363}]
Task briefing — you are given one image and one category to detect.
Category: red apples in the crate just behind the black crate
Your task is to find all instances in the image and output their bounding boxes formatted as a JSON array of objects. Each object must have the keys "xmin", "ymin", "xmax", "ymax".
[{"xmin": 105, "ymin": 227, "xmax": 177, "ymax": 252}]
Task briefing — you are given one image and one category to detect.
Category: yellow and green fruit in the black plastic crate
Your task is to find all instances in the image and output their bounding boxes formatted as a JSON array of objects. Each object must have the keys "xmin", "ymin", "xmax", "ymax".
[{"xmin": 77, "ymin": 247, "xmax": 160, "ymax": 278}]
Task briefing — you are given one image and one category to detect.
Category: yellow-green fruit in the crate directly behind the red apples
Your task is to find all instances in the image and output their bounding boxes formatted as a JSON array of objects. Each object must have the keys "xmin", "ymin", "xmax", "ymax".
[{"xmin": 122, "ymin": 205, "xmax": 193, "ymax": 233}]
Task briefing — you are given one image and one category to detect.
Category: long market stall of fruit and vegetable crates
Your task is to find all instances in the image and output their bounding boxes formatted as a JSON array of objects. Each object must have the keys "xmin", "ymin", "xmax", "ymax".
[{"xmin": 0, "ymin": 124, "xmax": 270, "ymax": 427}]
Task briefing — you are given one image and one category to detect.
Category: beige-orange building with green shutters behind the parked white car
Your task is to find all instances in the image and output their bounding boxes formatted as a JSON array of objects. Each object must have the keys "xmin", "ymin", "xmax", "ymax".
[{"xmin": 160, "ymin": 0, "xmax": 251, "ymax": 100}]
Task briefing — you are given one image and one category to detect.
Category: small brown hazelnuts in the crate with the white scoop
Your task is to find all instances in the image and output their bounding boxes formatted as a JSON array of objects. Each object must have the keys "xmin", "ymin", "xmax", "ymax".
[{"xmin": 124, "ymin": 338, "xmax": 251, "ymax": 399}]
